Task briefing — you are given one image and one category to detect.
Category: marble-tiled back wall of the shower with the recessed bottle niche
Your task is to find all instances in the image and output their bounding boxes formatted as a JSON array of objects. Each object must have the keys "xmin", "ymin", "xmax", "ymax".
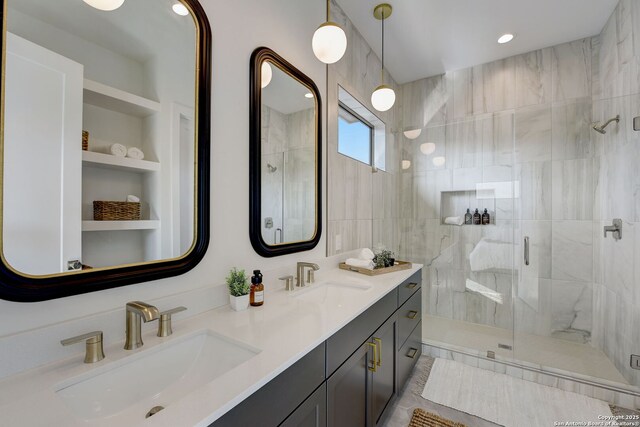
[{"xmin": 399, "ymin": 38, "xmax": 596, "ymax": 352}]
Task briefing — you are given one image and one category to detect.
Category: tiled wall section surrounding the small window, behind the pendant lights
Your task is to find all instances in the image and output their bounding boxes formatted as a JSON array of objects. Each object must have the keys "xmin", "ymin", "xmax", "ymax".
[{"xmin": 326, "ymin": 1, "xmax": 403, "ymax": 256}]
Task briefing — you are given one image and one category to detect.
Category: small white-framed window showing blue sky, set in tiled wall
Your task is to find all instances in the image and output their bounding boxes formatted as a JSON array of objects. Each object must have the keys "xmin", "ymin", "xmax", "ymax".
[{"xmin": 338, "ymin": 87, "xmax": 386, "ymax": 170}]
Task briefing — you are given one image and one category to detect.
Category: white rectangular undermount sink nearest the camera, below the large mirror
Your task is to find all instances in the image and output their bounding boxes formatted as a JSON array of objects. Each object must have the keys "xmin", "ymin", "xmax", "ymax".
[{"xmin": 55, "ymin": 330, "xmax": 260, "ymax": 421}]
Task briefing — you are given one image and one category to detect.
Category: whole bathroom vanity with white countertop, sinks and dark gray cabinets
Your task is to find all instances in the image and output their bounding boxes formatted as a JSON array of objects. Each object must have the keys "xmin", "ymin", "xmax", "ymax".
[{"xmin": 0, "ymin": 266, "xmax": 422, "ymax": 427}]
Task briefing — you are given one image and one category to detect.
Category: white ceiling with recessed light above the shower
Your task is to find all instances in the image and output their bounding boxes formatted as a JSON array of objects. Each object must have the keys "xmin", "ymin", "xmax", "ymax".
[{"xmin": 337, "ymin": 0, "xmax": 618, "ymax": 83}]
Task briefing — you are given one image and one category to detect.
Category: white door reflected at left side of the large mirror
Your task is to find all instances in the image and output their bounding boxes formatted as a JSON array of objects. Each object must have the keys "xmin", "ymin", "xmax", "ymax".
[{"xmin": 2, "ymin": 34, "xmax": 84, "ymax": 275}]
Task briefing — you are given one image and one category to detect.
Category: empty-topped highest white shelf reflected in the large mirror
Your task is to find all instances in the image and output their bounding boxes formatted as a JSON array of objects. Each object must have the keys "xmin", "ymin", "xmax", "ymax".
[{"xmin": 84, "ymin": 79, "xmax": 160, "ymax": 117}]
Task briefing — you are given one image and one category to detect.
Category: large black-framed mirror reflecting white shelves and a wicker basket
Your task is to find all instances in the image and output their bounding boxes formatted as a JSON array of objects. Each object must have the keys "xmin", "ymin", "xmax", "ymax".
[{"xmin": 0, "ymin": 0, "xmax": 211, "ymax": 301}]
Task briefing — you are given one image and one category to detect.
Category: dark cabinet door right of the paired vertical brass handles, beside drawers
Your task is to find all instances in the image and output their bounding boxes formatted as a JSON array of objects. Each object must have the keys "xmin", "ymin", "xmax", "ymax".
[{"xmin": 370, "ymin": 315, "xmax": 398, "ymax": 425}]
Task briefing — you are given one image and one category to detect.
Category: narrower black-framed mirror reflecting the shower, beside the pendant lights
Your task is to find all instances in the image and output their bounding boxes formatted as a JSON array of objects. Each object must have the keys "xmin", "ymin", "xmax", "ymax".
[{"xmin": 250, "ymin": 48, "xmax": 321, "ymax": 257}]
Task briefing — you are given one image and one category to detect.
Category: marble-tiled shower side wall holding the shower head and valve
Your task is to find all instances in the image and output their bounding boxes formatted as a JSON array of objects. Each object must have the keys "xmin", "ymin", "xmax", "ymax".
[{"xmin": 590, "ymin": 0, "xmax": 640, "ymax": 385}]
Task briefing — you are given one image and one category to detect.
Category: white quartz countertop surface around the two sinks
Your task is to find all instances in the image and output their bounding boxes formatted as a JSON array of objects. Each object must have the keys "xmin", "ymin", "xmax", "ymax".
[{"xmin": 0, "ymin": 264, "xmax": 422, "ymax": 427}]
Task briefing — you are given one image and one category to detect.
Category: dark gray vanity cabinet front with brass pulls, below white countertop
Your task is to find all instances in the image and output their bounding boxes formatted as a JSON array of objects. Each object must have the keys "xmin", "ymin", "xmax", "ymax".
[{"xmin": 210, "ymin": 271, "xmax": 422, "ymax": 427}]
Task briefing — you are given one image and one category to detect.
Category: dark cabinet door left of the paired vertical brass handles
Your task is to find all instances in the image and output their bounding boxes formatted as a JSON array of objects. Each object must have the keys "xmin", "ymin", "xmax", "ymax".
[{"xmin": 327, "ymin": 343, "xmax": 373, "ymax": 427}]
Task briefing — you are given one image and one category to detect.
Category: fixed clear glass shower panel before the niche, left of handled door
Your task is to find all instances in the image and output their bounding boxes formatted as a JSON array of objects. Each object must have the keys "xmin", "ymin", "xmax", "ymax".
[{"xmin": 401, "ymin": 112, "xmax": 516, "ymax": 358}]
